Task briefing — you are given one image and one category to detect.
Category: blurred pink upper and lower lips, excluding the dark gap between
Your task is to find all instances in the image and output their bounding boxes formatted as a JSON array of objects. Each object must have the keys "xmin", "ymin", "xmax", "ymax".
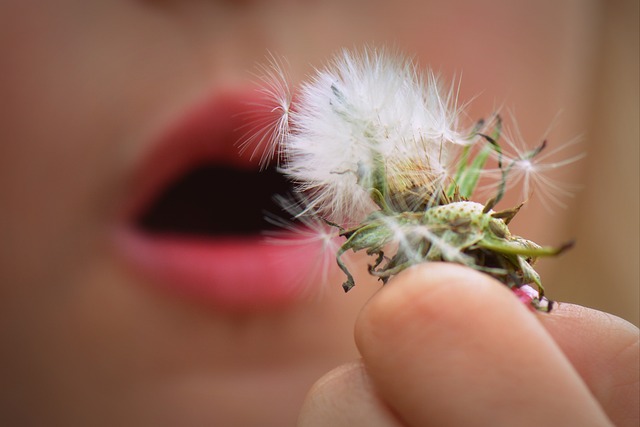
[{"xmin": 115, "ymin": 88, "xmax": 317, "ymax": 309}]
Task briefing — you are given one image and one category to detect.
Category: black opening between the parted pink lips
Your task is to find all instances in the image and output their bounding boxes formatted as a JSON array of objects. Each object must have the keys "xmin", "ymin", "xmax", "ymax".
[{"xmin": 135, "ymin": 165, "xmax": 292, "ymax": 236}]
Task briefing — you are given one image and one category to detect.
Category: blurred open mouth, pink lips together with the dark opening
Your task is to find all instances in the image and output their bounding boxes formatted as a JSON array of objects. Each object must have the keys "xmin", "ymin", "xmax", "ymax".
[{"xmin": 116, "ymin": 89, "xmax": 318, "ymax": 309}]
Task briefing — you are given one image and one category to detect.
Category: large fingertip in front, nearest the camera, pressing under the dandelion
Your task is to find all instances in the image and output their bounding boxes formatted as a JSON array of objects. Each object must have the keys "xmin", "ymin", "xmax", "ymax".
[{"xmin": 355, "ymin": 263, "xmax": 610, "ymax": 426}]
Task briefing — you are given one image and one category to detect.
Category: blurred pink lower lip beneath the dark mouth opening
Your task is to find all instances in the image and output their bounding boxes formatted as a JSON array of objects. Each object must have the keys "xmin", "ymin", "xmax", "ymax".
[{"xmin": 116, "ymin": 229, "xmax": 319, "ymax": 310}]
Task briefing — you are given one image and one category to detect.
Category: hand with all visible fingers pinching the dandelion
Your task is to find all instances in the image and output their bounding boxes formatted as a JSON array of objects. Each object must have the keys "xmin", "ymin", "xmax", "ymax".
[{"xmin": 299, "ymin": 263, "xmax": 639, "ymax": 427}]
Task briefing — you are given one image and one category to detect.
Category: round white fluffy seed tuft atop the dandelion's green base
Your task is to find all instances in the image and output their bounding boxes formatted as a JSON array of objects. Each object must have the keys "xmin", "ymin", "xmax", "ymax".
[{"xmin": 250, "ymin": 49, "xmax": 470, "ymax": 226}]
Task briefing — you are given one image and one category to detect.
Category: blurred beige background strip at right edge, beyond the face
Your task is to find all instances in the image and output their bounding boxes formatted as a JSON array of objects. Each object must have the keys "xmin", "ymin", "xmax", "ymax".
[{"xmin": 549, "ymin": 0, "xmax": 640, "ymax": 326}]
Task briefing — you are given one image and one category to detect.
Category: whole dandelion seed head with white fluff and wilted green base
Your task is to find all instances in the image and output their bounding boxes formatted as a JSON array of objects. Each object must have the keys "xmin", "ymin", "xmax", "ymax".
[{"xmin": 245, "ymin": 49, "xmax": 570, "ymax": 311}]
